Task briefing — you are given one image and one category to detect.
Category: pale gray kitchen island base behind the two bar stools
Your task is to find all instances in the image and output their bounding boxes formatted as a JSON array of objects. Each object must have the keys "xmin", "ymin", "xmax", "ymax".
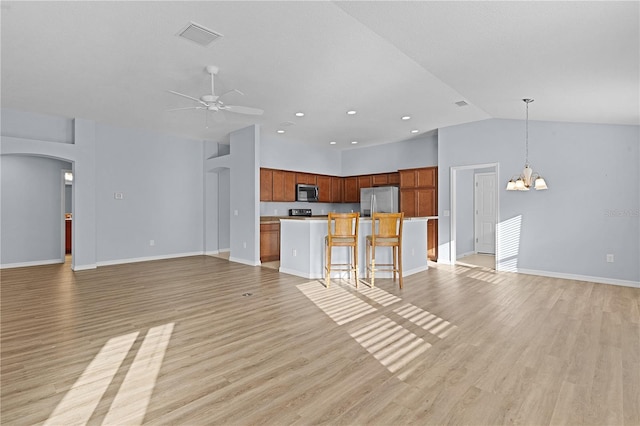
[{"xmin": 280, "ymin": 217, "xmax": 428, "ymax": 279}]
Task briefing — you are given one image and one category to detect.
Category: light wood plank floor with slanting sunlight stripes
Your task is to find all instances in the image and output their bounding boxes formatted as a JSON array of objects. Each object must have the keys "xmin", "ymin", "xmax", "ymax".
[{"xmin": 0, "ymin": 256, "xmax": 640, "ymax": 425}]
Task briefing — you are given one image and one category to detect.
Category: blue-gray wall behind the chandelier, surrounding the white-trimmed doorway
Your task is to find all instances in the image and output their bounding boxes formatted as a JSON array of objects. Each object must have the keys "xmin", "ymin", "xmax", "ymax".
[{"xmin": 438, "ymin": 119, "xmax": 640, "ymax": 285}]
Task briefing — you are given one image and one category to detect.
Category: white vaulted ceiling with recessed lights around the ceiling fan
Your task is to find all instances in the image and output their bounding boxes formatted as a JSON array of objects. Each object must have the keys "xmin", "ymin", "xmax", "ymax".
[{"xmin": 0, "ymin": 1, "xmax": 640, "ymax": 149}]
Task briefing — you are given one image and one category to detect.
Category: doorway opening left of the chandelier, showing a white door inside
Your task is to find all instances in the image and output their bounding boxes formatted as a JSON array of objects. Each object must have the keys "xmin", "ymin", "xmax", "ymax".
[{"xmin": 450, "ymin": 163, "xmax": 499, "ymax": 270}]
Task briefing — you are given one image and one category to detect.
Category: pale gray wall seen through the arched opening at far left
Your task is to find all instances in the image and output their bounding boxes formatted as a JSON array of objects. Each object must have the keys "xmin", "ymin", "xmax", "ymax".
[{"xmin": 0, "ymin": 155, "xmax": 71, "ymax": 266}]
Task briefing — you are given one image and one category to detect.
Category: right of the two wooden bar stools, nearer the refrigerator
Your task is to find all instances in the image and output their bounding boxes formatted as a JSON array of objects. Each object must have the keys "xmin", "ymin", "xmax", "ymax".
[{"xmin": 366, "ymin": 213, "xmax": 404, "ymax": 288}]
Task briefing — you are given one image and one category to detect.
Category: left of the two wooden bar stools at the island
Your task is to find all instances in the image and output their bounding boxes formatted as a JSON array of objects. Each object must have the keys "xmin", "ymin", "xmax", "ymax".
[{"xmin": 324, "ymin": 213, "xmax": 360, "ymax": 288}]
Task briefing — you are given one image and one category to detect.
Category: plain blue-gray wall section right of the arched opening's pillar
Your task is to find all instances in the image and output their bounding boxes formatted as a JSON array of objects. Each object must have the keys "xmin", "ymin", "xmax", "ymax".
[{"xmin": 96, "ymin": 124, "xmax": 204, "ymax": 263}]
